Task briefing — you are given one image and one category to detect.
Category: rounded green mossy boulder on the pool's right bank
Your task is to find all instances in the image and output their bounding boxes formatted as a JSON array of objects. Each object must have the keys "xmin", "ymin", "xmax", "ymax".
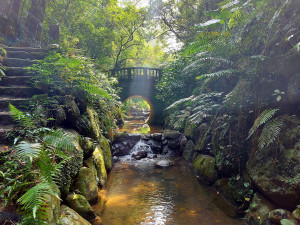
[{"xmin": 193, "ymin": 154, "xmax": 218, "ymax": 184}]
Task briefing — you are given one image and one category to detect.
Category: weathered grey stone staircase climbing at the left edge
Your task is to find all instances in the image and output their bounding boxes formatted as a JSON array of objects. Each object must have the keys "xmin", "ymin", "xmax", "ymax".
[{"xmin": 0, "ymin": 47, "xmax": 48, "ymax": 146}]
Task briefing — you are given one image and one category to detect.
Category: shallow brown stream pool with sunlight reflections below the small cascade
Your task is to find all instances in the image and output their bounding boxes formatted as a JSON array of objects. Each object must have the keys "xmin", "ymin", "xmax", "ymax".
[{"xmin": 101, "ymin": 157, "xmax": 244, "ymax": 225}]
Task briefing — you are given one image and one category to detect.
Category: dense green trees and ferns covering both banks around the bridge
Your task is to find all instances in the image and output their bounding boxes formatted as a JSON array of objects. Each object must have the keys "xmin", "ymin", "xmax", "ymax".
[{"xmin": 0, "ymin": 0, "xmax": 300, "ymax": 224}]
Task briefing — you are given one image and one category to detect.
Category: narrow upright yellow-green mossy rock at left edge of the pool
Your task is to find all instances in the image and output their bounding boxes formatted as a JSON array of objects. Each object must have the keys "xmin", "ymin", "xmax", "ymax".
[{"xmin": 93, "ymin": 146, "xmax": 107, "ymax": 187}]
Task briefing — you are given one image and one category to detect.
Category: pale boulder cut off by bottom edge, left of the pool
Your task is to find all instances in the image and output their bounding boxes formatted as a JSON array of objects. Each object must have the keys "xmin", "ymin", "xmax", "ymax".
[{"xmin": 57, "ymin": 205, "xmax": 91, "ymax": 225}]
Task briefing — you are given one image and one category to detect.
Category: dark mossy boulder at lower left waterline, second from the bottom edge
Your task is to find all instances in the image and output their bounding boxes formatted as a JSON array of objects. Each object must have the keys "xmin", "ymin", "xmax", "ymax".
[{"xmin": 66, "ymin": 194, "xmax": 96, "ymax": 221}]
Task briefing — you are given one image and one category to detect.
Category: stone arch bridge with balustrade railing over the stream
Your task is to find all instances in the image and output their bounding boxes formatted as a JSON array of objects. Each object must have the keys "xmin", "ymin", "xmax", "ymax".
[{"xmin": 109, "ymin": 67, "xmax": 164, "ymax": 124}]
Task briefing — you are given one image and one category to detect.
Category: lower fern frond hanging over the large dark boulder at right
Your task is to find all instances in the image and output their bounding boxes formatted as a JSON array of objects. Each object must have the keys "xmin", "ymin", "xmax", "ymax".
[{"xmin": 258, "ymin": 117, "xmax": 283, "ymax": 149}]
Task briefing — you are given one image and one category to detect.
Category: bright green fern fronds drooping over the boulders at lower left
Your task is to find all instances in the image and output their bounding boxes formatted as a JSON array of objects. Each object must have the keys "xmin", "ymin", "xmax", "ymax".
[{"xmin": 6, "ymin": 130, "xmax": 75, "ymax": 224}]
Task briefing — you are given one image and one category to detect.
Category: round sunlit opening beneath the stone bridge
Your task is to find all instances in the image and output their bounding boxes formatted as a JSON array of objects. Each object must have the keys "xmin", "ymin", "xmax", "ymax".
[{"xmin": 122, "ymin": 95, "xmax": 154, "ymax": 123}]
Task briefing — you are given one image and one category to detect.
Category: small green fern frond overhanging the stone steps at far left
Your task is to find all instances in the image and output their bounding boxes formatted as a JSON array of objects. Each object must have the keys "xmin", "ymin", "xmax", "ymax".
[{"xmin": 9, "ymin": 104, "xmax": 36, "ymax": 130}]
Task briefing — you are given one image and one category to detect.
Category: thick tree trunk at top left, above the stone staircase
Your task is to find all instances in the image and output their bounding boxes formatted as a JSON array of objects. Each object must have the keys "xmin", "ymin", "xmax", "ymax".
[{"xmin": 26, "ymin": 0, "xmax": 47, "ymax": 45}]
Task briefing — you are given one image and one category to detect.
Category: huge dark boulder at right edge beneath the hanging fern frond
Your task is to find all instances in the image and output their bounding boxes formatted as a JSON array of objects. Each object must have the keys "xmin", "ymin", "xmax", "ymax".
[{"xmin": 247, "ymin": 118, "xmax": 300, "ymax": 210}]
